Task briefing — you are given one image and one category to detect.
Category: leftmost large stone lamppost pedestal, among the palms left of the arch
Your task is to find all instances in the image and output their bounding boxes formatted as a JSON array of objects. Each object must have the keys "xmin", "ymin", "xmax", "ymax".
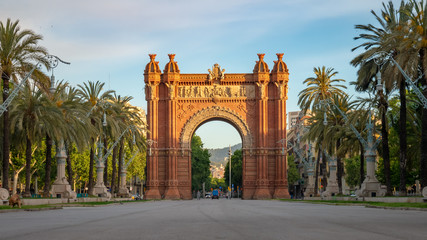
[{"xmin": 51, "ymin": 141, "xmax": 77, "ymax": 199}]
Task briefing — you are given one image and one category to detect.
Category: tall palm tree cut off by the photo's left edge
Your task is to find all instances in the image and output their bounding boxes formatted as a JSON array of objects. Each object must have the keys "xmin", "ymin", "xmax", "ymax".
[{"xmin": 0, "ymin": 19, "xmax": 48, "ymax": 189}]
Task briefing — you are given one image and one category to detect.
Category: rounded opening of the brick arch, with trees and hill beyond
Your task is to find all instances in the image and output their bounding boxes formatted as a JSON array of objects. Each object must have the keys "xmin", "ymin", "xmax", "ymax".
[{"xmin": 191, "ymin": 118, "xmax": 243, "ymax": 199}]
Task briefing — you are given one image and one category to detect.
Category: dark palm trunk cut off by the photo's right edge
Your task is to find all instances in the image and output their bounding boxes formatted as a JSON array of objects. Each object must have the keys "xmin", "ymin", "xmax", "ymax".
[{"xmin": 420, "ymin": 48, "xmax": 427, "ymax": 187}]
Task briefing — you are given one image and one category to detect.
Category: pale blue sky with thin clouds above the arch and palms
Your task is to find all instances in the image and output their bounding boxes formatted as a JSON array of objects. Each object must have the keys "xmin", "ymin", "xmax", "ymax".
[{"xmin": 0, "ymin": 0, "xmax": 399, "ymax": 148}]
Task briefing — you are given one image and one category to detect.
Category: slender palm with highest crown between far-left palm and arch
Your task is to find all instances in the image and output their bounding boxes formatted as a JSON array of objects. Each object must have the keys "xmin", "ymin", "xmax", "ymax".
[{"xmin": 77, "ymin": 81, "xmax": 114, "ymax": 192}]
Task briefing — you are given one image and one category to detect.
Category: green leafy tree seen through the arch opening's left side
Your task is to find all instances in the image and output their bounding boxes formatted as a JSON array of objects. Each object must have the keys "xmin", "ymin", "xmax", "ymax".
[{"xmin": 191, "ymin": 135, "xmax": 211, "ymax": 191}]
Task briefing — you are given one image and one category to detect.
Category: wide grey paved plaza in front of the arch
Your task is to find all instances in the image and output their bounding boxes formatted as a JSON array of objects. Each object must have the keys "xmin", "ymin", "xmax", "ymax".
[{"xmin": 0, "ymin": 199, "xmax": 427, "ymax": 240}]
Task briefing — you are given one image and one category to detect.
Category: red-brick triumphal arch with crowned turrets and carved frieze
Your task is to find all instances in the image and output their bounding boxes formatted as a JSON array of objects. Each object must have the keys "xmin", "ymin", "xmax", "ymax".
[{"xmin": 144, "ymin": 54, "xmax": 289, "ymax": 199}]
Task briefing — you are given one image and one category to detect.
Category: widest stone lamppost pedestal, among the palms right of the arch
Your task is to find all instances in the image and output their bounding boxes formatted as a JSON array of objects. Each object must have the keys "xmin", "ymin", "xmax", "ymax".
[{"xmin": 356, "ymin": 154, "xmax": 387, "ymax": 197}]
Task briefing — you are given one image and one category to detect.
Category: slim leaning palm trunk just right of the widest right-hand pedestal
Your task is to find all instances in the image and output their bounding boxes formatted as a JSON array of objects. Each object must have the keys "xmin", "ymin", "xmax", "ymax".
[{"xmin": 379, "ymin": 92, "xmax": 393, "ymax": 196}]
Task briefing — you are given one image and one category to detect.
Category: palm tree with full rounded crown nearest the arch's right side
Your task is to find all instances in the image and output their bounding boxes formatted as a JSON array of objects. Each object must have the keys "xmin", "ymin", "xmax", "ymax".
[{"xmin": 298, "ymin": 66, "xmax": 347, "ymax": 194}]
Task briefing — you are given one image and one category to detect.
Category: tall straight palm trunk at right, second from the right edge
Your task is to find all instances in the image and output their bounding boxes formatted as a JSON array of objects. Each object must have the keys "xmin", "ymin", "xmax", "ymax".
[{"xmin": 399, "ymin": 79, "xmax": 407, "ymax": 196}]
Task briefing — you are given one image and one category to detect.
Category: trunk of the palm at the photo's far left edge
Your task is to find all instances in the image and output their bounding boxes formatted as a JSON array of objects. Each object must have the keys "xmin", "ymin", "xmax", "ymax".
[{"xmin": 1, "ymin": 72, "xmax": 10, "ymax": 189}]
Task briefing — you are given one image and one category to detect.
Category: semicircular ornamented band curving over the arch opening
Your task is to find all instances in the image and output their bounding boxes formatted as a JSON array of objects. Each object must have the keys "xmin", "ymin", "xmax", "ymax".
[{"xmin": 180, "ymin": 106, "xmax": 252, "ymax": 149}]
